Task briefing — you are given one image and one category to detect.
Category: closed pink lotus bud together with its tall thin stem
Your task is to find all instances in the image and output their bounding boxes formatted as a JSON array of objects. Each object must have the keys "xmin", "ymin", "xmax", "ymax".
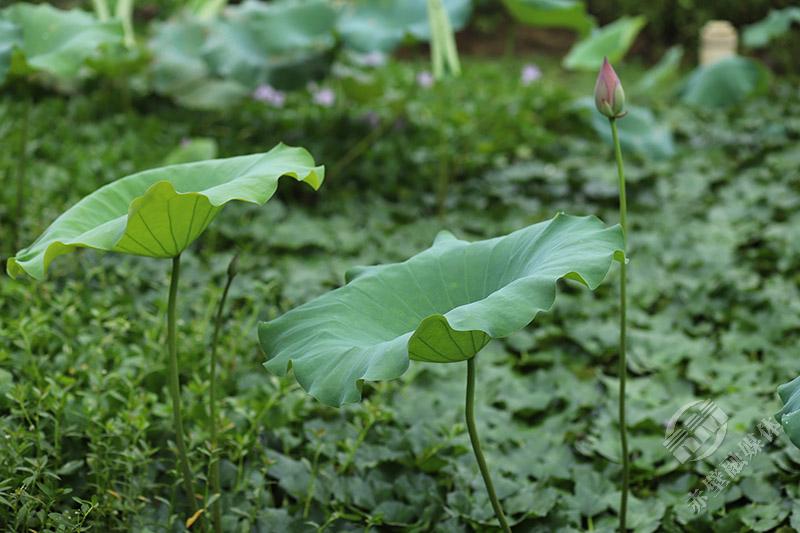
[{"xmin": 594, "ymin": 58, "xmax": 630, "ymax": 532}]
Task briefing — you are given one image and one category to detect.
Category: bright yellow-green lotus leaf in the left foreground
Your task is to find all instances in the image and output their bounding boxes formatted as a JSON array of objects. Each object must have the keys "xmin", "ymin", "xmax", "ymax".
[{"xmin": 7, "ymin": 144, "xmax": 324, "ymax": 279}]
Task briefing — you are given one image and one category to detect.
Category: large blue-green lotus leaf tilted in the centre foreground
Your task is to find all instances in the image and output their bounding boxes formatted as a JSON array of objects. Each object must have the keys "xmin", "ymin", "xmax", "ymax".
[{"xmin": 259, "ymin": 214, "xmax": 622, "ymax": 405}]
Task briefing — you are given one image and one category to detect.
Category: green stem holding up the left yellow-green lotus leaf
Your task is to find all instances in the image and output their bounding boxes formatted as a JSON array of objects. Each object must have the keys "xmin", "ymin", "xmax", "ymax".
[{"xmin": 167, "ymin": 254, "xmax": 197, "ymax": 514}]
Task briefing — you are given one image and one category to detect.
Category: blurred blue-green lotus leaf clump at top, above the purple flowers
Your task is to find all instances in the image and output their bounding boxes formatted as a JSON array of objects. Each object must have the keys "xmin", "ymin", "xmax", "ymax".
[{"xmin": 150, "ymin": 0, "xmax": 336, "ymax": 109}]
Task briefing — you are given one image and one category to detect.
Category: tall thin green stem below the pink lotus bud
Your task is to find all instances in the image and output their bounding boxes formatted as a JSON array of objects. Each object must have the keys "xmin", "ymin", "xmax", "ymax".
[{"xmin": 609, "ymin": 118, "xmax": 630, "ymax": 533}]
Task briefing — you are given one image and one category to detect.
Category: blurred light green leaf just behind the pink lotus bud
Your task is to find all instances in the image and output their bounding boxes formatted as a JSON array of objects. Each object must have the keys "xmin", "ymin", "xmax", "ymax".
[{"xmin": 564, "ymin": 17, "xmax": 647, "ymax": 71}]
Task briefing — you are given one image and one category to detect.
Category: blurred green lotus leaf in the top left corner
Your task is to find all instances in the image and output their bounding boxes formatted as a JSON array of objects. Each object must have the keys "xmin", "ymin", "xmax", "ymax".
[{"xmin": 0, "ymin": 4, "xmax": 123, "ymax": 79}]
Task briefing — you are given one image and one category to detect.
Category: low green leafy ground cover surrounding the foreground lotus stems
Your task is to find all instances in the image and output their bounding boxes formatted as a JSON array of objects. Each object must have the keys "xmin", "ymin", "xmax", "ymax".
[{"xmin": 0, "ymin": 61, "xmax": 800, "ymax": 532}]
